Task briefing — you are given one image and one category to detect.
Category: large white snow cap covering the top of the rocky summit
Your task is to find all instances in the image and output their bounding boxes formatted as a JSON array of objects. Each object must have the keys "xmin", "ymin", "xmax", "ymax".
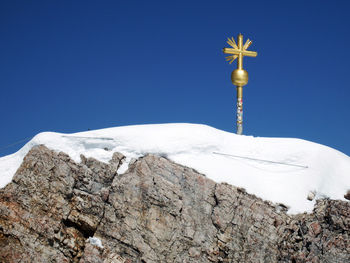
[{"xmin": 0, "ymin": 123, "xmax": 350, "ymax": 214}]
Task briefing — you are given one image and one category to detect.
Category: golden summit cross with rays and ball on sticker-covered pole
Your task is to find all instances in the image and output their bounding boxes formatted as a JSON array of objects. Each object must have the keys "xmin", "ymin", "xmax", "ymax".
[{"xmin": 223, "ymin": 34, "xmax": 258, "ymax": 134}]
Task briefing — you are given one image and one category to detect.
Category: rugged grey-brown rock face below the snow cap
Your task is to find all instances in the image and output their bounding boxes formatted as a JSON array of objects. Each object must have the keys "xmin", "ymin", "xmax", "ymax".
[{"xmin": 0, "ymin": 146, "xmax": 350, "ymax": 263}]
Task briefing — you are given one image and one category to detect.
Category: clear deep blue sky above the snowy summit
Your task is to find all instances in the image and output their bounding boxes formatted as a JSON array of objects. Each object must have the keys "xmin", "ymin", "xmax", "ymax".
[{"xmin": 0, "ymin": 0, "xmax": 350, "ymax": 156}]
